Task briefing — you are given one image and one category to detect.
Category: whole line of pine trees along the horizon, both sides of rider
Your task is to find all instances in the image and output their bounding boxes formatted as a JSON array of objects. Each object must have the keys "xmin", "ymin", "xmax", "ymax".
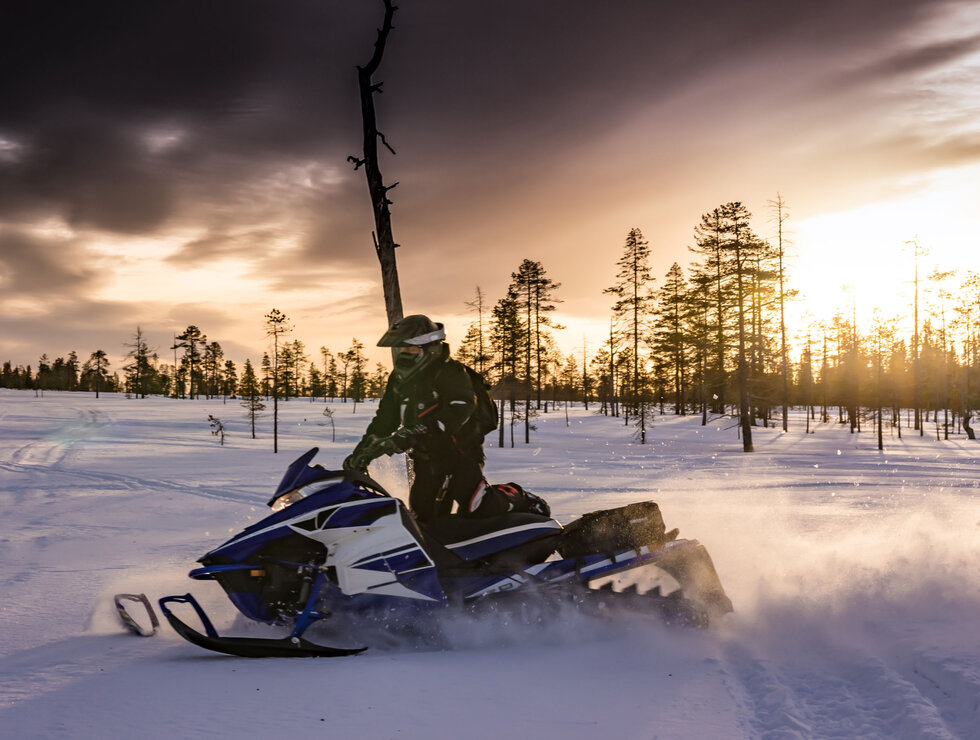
[{"xmin": 0, "ymin": 196, "xmax": 980, "ymax": 451}]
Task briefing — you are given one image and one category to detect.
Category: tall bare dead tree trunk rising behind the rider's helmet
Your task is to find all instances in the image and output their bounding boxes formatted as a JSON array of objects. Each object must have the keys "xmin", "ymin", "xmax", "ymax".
[{"xmin": 347, "ymin": 0, "xmax": 402, "ymax": 325}]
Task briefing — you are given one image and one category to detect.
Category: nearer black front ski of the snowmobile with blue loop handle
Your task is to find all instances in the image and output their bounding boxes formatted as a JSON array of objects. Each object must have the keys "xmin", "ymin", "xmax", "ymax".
[{"xmin": 159, "ymin": 594, "xmax": 367, "ymax": 658}]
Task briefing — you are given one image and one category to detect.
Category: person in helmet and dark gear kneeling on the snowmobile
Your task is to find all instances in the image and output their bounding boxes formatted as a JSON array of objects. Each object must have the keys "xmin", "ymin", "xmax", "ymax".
[{"xmin": 344, "ymin": 314, "xmax": 550, "ymax": 521}]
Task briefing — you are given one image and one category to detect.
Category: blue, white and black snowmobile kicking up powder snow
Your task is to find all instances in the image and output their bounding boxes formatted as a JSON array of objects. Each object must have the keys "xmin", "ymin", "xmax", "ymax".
[{"xmin": 122, "ymin": 447, "xmax": 732, "ymax": 657}]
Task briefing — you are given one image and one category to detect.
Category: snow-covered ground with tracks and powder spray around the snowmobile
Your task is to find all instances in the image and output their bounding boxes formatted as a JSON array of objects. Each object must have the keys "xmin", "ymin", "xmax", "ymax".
[{"xmin": 0, "ymin": 389, "xmax": 980, "ymax": 740}]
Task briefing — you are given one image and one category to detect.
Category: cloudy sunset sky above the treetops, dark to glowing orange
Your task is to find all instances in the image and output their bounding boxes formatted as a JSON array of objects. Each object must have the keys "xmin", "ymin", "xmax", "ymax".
[{"xmin": 0, "ymin": 0, "xmax": 980, "ymax": 365}]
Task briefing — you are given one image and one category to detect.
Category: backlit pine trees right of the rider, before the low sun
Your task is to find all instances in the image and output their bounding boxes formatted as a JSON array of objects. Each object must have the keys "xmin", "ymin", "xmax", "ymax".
[{"xmin": 458, "ymin": 196, "xmax": 980, "ymax": 452}]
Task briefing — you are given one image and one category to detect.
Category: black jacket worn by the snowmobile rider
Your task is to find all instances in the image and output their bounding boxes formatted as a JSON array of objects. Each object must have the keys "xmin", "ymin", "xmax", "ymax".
[{"xmin": 358, "ymin": 345, "xmax": 484, "ymax": 460}]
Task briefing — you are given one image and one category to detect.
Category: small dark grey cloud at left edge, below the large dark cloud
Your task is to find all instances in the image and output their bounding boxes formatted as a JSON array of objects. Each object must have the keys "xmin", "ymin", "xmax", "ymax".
[{"xmin": 0, "ymin": 229, "xmax": 99, "ymax": 300}]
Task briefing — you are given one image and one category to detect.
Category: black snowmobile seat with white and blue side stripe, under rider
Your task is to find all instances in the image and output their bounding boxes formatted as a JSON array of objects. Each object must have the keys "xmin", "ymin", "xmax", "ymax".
[{"xmin": 421, "ymin": 512, "xmax": 562, "ymax": 564}]
